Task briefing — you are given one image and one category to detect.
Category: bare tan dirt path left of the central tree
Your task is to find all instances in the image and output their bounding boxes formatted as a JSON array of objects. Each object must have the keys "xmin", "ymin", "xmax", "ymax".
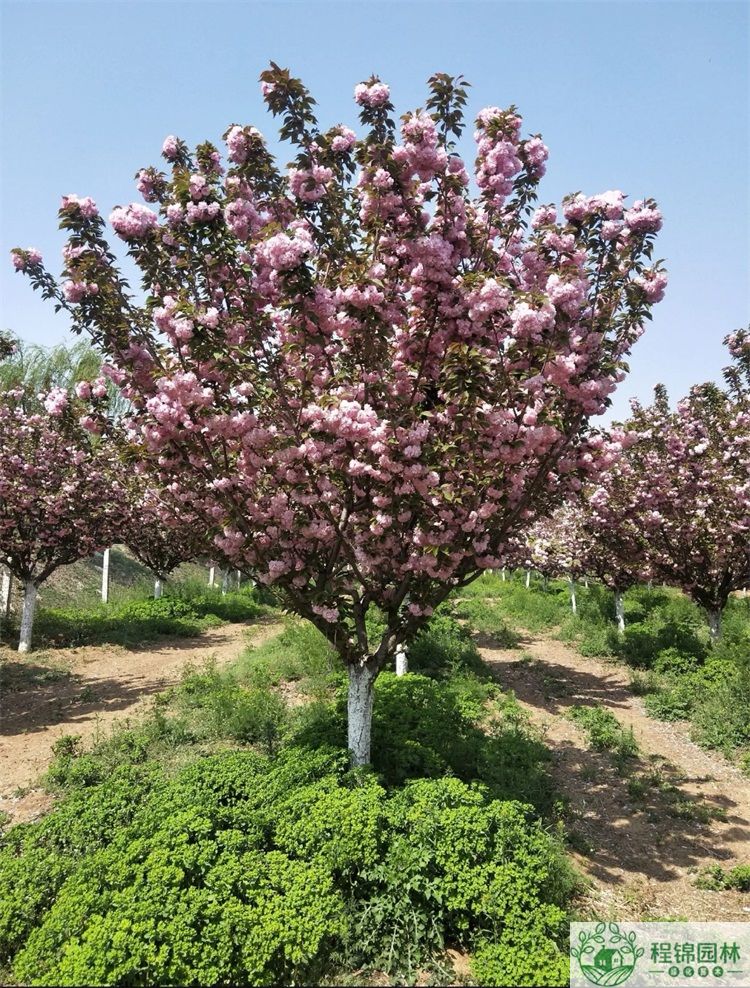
[{"xmin": 0, "ymin": 622, "xmax": 279, "ymax": 821}]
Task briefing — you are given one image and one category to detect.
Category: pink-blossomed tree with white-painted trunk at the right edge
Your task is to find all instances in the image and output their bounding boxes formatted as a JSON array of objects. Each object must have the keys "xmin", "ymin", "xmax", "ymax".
[{"xmin": 627, "ymin": 376, "xmax": 750, "ymax": 641}]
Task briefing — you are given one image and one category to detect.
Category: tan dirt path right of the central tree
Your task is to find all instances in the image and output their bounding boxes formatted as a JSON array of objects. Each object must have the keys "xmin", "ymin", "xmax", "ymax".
[{"xmin": 479, "ymin": 635, "xmax": 750, "ymax": 922}]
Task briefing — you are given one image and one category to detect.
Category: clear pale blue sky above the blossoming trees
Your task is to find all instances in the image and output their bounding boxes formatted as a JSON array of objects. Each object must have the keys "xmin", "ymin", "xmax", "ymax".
[{"xmin": 0, "ymin": 0, "xmax": 750, "ymax": 415}]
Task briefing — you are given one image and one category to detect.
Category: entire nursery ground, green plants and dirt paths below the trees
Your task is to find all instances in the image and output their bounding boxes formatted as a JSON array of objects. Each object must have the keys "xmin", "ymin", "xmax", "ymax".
[{"xmin": 0, "ymin": 574, "xmax": 750, "ymax": 985}]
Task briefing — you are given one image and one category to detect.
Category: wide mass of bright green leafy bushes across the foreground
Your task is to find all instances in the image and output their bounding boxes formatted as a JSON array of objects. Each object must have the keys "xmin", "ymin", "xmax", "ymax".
[{"xmin": 0, "ymin": 745, "xmax": 575, "ymax": 985}]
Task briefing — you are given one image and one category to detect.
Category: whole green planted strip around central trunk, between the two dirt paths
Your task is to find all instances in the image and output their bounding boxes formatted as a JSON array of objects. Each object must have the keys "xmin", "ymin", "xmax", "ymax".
[{"xmin": 0, "ymin": 617, "xmax": 577, "ymax": 985}]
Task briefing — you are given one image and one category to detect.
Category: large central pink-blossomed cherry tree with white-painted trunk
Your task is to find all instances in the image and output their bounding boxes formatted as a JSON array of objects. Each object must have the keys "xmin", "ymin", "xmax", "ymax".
[{"xmin": 14, "ymin": 65, "xmax": 666, "ymax": 764}]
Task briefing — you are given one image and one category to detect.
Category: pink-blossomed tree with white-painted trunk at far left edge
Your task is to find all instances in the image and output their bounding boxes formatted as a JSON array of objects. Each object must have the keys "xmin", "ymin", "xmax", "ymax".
[{"xmin": 0, "ymin": 382, "xmax": 124, "ymax": 652}]
